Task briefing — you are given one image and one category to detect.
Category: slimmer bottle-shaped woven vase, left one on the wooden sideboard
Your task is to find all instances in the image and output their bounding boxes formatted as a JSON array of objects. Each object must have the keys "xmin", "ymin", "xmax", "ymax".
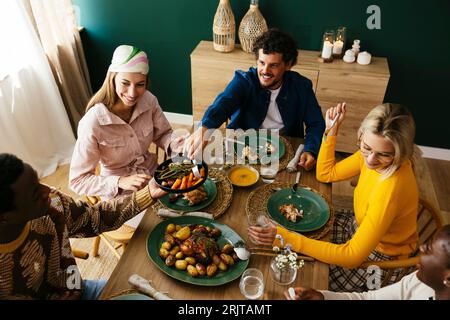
[{"xmin": 213, "ymin": 0, "xmax": 236, "ymax": 52}]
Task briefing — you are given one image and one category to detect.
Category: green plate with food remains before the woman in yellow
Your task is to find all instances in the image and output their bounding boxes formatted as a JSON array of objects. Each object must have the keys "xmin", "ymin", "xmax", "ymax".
[{"xmin": 267, "ymin": 188, "xmax": 330, "ymax": 232}]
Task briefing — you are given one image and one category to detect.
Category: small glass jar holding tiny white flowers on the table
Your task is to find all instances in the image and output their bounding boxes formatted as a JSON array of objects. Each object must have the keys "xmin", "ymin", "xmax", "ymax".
[{"xmin": 270, "ymin": 234, "xmax": 305, "ymax": 285}]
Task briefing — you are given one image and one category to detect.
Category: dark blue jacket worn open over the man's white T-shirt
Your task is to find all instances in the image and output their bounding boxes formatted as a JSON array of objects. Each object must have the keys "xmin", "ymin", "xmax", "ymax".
[{"xmin": 202, "ymin": 68, "xmax": 325, "ymax": 156}]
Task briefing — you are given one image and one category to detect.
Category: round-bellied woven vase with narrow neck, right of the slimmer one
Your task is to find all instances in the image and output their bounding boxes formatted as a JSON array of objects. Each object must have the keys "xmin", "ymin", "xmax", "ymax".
[{"xmin": 239, "ymin": 0, "xmax": 268, "ymax": 52}]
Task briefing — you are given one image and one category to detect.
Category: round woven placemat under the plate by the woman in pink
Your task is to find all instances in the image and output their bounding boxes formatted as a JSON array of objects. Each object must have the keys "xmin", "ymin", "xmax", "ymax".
[{"xmin": 152, "ymin": 168, "xmax": 233, "ymax": 219}]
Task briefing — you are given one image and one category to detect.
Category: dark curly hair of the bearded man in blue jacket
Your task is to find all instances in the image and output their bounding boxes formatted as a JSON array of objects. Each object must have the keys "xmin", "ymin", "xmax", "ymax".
[{"xmin": 253, "ymin": 28, "xmax": 298, "ymax": 66}]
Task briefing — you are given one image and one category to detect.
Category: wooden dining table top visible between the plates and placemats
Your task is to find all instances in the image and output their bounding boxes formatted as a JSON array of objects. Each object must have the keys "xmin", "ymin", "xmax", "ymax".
[{"xmin": 100, "ymin": 137, "xmax": 331, "ymax": 300}]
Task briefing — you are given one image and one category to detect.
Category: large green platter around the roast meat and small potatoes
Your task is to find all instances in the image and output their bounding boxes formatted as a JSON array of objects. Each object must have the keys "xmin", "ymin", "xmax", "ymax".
[{"xmin": 147, "ymin": 217, "xmax": 249, "ymax": 286}]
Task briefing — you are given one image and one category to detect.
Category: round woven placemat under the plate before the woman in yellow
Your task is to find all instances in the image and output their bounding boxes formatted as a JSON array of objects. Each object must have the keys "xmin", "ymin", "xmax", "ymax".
[{"xmin": 245, "ymin": 182, "xmax": 334, "ymax": 239}]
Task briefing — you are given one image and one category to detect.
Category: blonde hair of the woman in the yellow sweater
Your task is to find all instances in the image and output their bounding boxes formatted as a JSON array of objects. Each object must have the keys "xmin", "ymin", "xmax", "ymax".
[{"xmin": 358, "ymin": 103, "xmax": 420, "ymax": 179}]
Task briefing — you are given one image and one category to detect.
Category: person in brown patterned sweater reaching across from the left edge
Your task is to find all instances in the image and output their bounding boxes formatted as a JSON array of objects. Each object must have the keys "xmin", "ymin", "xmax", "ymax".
[{"xmin": 0, "ymin": 154, "xmax": 165, "ymax": 299}]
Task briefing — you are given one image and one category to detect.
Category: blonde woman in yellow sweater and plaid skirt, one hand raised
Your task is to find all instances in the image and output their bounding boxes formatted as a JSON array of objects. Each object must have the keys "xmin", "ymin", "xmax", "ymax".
[{"xmin": 248, "ymin": 103, "xmax": 419, "ymax": 291}]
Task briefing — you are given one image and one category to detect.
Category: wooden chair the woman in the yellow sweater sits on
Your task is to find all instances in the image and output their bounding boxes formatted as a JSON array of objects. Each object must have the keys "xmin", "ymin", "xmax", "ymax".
[{"xmin": 359, "ymin": 199, "xmax": 442, "ymax": 287}]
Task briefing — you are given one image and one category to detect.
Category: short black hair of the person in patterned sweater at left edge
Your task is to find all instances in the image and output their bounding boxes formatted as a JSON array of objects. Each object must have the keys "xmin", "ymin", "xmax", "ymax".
[{"xmin": 0, "ymin": 153, "xmax": 25, "ymax": 214}]
